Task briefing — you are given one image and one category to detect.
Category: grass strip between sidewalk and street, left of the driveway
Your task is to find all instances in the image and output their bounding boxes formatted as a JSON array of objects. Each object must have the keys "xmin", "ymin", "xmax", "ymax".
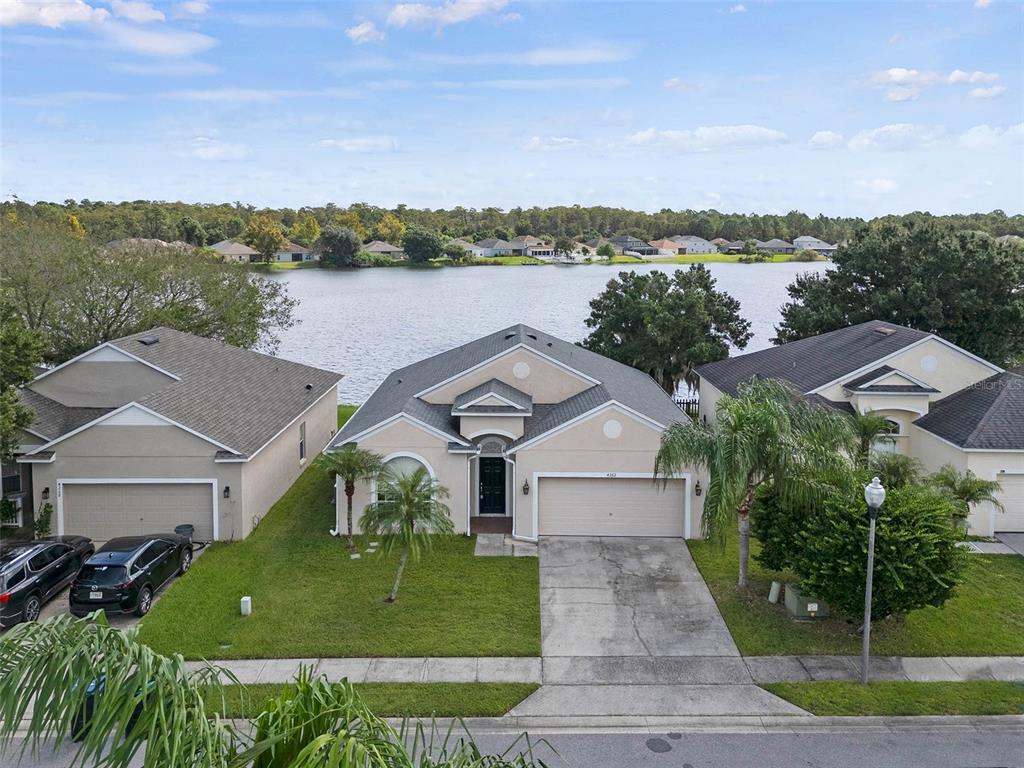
[{"xmin": 201, "ymin": 683, "xmax": 539, "ymax": 718}]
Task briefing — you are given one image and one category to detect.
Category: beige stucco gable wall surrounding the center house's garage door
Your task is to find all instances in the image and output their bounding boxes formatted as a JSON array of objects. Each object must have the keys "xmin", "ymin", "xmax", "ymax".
[{"xmin": 513, "ymin": 407, "xmax": 708, "ymax": 539}]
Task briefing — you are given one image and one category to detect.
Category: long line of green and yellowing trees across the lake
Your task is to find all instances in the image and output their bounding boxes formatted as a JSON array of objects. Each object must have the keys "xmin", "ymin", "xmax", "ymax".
[{"xmin": 8, "ymin": 200, "xmax": 1024, "ymax": 246}]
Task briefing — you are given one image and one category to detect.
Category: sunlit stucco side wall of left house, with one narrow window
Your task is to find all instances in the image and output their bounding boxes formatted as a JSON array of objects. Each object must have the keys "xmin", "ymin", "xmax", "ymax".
[{"xmin": 240, "ymin": 387, "xmax": 338, "ymax": 538}]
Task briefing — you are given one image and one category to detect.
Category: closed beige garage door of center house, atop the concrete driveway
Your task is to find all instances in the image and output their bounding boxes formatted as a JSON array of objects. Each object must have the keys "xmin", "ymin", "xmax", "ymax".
[{"xmin": 538, "ymin": 477, "xmax": 686, "ymax": 537}]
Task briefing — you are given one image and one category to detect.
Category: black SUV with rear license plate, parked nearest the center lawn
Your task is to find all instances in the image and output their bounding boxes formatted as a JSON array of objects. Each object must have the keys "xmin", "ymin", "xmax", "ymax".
[{"xmin": 71, "ymin": 534, "xmax": 193, "ymax": 616}]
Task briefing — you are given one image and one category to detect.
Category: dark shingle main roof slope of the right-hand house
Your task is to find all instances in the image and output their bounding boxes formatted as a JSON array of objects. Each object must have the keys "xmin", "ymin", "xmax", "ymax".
[{"xmin": 697, "ymin": 321, "xmax": 931, "ymax": 395}]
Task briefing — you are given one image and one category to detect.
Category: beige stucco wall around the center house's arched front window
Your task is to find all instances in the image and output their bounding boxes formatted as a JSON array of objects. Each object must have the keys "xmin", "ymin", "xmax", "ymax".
[{"xmin": 344, "ymin": 421, "xmax": 468, "ymax": 534}]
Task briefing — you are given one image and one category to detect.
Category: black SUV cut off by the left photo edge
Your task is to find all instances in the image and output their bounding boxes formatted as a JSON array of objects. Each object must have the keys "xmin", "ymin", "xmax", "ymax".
[{"xmin": 0, "ymin": 536, "xmax": 95, "ymax": 627}]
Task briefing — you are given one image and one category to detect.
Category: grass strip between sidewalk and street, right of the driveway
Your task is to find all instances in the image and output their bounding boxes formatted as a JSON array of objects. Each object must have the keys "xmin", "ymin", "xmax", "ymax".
[{"xmin": 761, "ymin": 680, "xmax": 1024, "ymax": 716}]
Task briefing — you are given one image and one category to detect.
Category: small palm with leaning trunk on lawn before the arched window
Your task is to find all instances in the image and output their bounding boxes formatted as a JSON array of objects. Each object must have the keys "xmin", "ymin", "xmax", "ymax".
[{"xmin": 360, "ymin": 467, "xmax": 454, "ymax": 603}]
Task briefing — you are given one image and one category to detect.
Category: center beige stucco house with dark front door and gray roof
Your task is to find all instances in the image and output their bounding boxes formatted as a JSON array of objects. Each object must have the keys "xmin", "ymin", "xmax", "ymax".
[{"xmin": 328, "ymin": 325, "xmax": 707, "ymax": 541}]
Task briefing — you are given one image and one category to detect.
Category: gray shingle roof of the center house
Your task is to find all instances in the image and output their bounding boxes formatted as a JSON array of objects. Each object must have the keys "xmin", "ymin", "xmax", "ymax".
[{"xmin": 331, "ymin": 325, "xmax": 681, "ymax": 446}]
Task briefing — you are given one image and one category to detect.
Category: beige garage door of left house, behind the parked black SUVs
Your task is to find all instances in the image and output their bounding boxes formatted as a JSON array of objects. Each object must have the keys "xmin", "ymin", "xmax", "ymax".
[{"xmin": 62, "ymin": 483, "xmax": 213, "ymax": 542}]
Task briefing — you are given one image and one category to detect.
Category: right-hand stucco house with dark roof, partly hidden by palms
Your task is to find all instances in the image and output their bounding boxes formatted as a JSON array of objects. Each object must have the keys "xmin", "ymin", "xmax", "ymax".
[{"xmin": 697, "ymin": 321, "xmax": 1024, "ymax": 536}]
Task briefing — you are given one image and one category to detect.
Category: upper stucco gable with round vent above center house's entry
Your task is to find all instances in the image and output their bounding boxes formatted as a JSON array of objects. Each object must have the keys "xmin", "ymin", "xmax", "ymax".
[{"xmin": 423, "ymin": 349, "xmax": 594, "ymax": 403}]
